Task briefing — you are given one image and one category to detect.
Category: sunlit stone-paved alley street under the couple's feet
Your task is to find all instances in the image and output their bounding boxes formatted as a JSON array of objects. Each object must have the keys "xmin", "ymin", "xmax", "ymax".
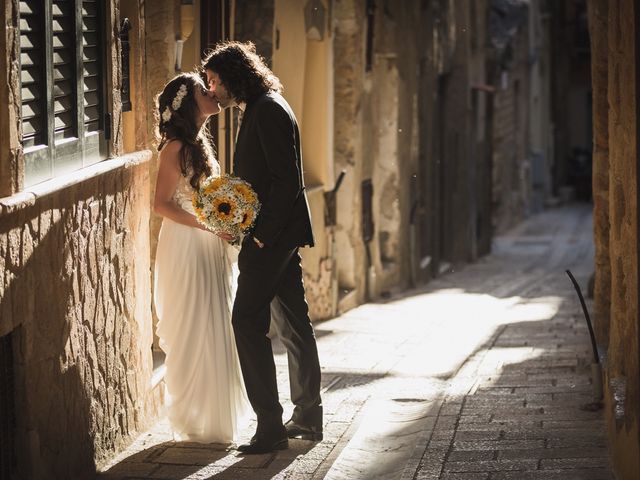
[{"xmin": 100, "ymin": 205, "xmax": 612, "ymax": 480}]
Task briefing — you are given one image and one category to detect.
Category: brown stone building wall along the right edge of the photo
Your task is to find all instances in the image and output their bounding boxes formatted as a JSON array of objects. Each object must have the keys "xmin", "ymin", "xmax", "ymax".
[{"xmin": 589, "ymin": 0, "xmax": 640, "ymax": 480}]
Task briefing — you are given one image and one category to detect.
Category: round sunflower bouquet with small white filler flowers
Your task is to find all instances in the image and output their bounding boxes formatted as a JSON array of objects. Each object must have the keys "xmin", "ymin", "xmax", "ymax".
[{"xmin": 191, "ymin": 175, "xmax": 260, "ymax": 238}]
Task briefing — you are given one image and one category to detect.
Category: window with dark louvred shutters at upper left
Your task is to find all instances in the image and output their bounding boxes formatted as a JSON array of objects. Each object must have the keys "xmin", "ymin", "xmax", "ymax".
[{"xmin": 20, "ymin": 0, "xmax": 109, "ymax": 186}]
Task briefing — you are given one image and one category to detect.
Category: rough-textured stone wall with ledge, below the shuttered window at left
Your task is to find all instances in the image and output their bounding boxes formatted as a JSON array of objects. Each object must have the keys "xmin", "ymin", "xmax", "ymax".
[{"xmin": 0, "ymin": 153, "xmax": 151, "ymax": 479}]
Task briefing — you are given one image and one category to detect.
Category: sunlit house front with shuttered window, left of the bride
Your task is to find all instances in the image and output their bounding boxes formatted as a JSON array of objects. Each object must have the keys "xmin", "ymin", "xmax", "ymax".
[{"xmin": 0, "ymin": 0, "xmax": 159, "ymax": 479}]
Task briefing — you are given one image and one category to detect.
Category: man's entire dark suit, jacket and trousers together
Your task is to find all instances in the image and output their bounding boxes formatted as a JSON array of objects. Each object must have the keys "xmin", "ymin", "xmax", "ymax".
[{"xmin": 232, "ymin": 92, "xmax": 322, "ymax": 431}]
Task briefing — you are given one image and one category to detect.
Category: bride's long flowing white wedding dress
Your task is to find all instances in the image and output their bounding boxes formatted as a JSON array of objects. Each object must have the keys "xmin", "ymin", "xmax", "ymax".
[{"xmin": 154, "ymin": 165, "xmax": 250, "ymax": 443}]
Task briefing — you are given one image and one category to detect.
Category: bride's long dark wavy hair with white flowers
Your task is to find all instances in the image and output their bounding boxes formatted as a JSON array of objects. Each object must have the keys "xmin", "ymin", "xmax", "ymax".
[{"xmin": 155, "ymin": 73, "xmax": 214, "ymax": 189}]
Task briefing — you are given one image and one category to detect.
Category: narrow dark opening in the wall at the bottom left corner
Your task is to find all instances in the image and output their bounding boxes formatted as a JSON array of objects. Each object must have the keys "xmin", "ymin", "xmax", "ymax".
[{"xmin": 0, "ymin": 335, "xmax": 16, "ymax": 480}]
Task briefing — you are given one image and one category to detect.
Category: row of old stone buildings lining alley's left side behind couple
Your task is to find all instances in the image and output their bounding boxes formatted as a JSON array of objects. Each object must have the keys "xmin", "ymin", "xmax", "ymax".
[{"xmin": 0, "ymin": 0, "xmax": 592, "ymax": 480}]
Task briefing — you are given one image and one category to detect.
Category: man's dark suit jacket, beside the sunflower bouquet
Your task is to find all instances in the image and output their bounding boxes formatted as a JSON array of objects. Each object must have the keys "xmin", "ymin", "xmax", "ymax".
[{"xmin": 234, "ymin": 92, "xmax": 314, "ymax": 248}]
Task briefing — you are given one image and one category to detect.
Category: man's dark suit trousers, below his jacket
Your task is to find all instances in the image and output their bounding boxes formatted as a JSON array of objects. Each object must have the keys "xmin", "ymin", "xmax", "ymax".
[{"xmin": 233, "ymin": 239, "xmax": 322, "ymax": 428}]
